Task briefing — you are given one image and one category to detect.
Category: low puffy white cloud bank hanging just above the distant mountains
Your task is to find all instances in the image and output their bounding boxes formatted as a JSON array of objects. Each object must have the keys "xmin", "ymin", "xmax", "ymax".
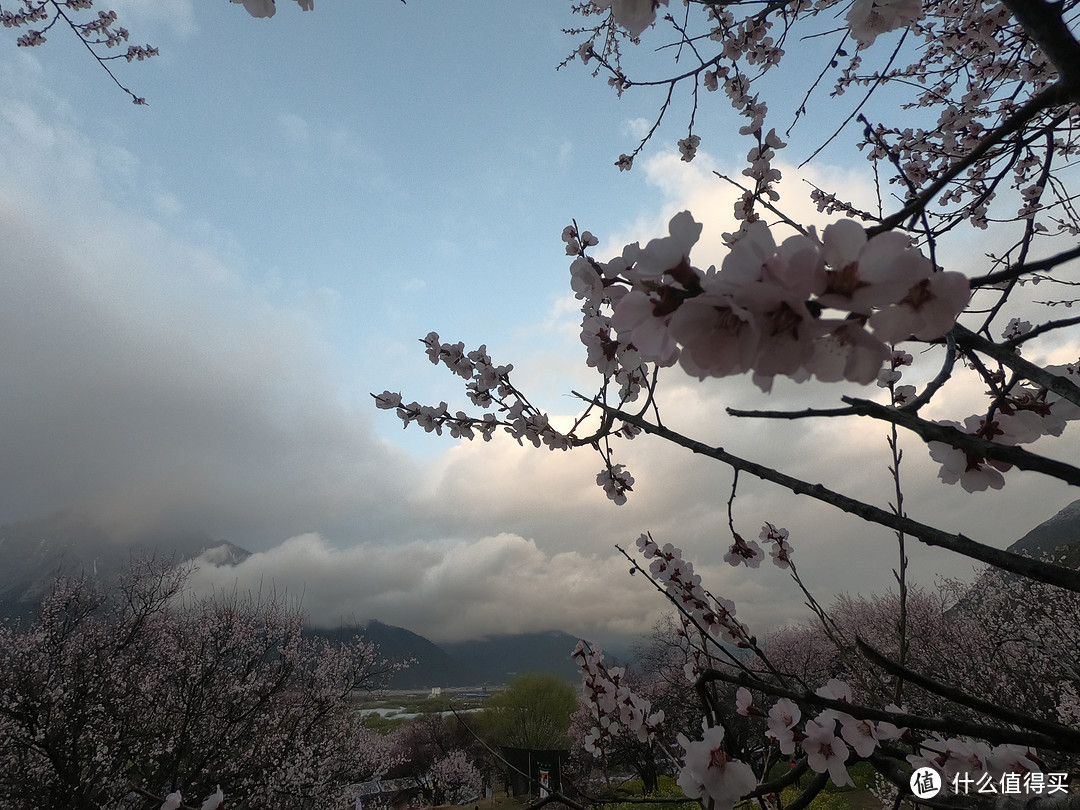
[{"xmin": 191, "ymin": 534, "xmax": 658, "ymax": 654}]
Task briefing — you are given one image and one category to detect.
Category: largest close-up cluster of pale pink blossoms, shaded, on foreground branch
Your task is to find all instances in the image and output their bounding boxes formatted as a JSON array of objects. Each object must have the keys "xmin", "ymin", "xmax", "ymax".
[{"xmin": 570, "ymin": 212, "xmax": 969, "ymax": 394}]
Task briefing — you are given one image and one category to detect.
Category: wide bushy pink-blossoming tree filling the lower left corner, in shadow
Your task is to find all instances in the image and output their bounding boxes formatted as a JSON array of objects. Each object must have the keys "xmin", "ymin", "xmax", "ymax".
[{"xmin": 0, "ymin": 563, "xmax": 395, "ymax": 810}]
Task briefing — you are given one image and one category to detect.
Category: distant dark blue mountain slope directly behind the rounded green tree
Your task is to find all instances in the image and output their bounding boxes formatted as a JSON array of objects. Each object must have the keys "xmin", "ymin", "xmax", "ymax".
[{"xmin": 440, "ymin": 630, "xmax": 581, "ymax": 684}]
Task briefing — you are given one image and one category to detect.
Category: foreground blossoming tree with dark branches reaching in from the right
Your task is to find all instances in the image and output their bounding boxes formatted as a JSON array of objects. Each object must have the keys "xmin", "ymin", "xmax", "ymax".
[{"xmin": 375, "ymin": 0, "xmax": 1080, "ymax": 808}]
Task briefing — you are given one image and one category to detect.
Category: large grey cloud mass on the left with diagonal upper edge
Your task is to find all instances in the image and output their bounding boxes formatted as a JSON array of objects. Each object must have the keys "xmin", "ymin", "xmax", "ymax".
[{"xmin": 0, "ymin": 65, "xmax": 421, "ymax": 545}]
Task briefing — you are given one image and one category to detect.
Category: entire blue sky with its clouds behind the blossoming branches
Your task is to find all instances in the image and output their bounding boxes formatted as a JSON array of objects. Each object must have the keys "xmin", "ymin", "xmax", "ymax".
[{"xmin": 0, "ymin": 0, "xmax": 1076, "ymax": 638}]
